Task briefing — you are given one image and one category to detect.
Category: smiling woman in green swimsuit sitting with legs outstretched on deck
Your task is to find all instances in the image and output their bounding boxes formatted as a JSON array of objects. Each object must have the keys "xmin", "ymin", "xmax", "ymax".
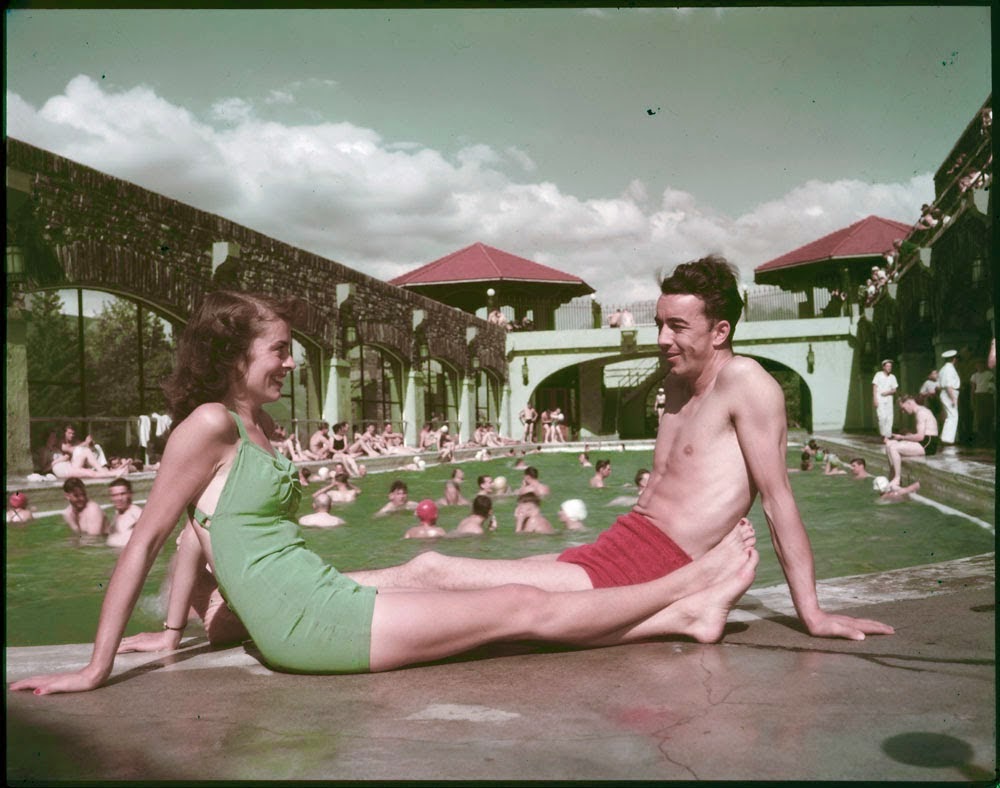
[{"xmin": 11, "ymin": 292, "xmax": 758, "ymax": 695}]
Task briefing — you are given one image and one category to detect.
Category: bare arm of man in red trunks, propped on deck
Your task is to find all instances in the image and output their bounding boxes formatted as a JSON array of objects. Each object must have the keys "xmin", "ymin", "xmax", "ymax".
[{"xmin": 719, "ymin": 362, "xmax": 893, "ymax": 640}]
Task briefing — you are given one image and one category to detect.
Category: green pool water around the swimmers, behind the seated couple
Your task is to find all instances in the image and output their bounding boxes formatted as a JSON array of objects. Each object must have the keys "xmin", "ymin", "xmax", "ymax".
[{"xmin": 6, "ymin": 451, "xmax": 994, "ymax": 646}]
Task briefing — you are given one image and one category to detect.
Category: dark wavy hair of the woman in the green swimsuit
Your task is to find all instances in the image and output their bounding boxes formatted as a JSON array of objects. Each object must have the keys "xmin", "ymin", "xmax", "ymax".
[{"xmin": 163, "ymin": 290, "xmax": 298, "ymax": 423}]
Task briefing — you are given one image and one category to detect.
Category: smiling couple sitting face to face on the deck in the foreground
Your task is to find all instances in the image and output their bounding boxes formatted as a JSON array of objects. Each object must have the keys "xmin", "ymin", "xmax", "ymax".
[{"xmin": 11, "ymin": 257, "xmax": 893, "ymax": 694}]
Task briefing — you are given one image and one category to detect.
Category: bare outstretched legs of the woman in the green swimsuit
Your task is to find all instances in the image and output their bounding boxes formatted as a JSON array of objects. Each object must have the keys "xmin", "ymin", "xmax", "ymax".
[{"xmin": 370, "ymin": 548, "xmax": 759, "ymax": 671}]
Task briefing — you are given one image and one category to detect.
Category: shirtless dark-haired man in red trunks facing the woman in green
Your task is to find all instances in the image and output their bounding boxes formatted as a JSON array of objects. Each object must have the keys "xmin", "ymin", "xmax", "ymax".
[{"xmin": 349, "ymin": 257, "xmax": 893, "ymax": 640}]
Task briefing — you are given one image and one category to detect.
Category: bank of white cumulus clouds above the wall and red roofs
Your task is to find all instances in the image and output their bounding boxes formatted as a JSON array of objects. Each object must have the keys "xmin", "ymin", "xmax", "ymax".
[{"xmin": 7, "ymin": 76, "xmax": 933, "ymax": 302}]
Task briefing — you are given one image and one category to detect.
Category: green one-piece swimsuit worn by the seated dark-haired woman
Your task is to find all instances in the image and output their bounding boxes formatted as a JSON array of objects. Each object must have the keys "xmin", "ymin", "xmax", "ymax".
[{"xmin": 194, "ymin": 413, "xmax": 376, "ymax": 673}]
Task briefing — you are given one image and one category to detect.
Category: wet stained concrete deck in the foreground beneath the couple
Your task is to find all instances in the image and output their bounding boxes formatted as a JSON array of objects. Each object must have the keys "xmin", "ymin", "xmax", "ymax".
[{"xmin": 6, "ymin": 553, "xmax": 997, "ymax": 784}]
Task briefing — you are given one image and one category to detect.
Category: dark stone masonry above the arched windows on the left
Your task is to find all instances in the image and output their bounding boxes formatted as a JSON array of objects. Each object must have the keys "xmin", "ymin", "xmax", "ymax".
[{"xmin": 6, "ymin": 138, "xmax": 507, "ymax": 379}]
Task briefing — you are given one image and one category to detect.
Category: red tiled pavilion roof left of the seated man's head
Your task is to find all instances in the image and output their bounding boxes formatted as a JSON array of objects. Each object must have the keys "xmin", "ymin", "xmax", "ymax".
[{"xmin": 389, "ymin": 243, "xmax": 586, "ymax": 287}]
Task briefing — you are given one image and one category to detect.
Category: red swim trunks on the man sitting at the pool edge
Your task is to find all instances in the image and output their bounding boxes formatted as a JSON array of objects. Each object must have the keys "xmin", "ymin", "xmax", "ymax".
[{"xmin": 557, "ymin": 512, "xmax": 693, "ymax": 588}]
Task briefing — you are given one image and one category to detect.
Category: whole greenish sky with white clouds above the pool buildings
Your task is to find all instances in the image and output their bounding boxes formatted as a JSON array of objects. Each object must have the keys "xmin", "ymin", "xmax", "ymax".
[{"xmin": 5, "ymin": 7, "xmax": 991, "ymax": 303}]
